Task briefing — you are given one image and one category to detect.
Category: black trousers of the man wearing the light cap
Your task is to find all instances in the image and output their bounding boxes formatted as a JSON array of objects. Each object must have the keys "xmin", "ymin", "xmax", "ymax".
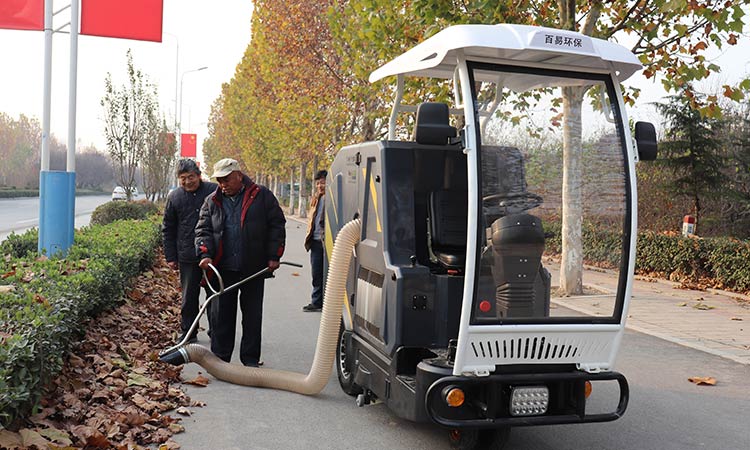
[{"xmin": 209, "ymin": 270, "xmax": 264, "ymax": 364}]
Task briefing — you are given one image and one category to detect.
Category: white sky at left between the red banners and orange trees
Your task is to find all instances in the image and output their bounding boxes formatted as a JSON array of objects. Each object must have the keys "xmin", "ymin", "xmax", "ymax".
[{"xmin": 0, "ymin": 0, "xmax": 252, "ymax": 165}]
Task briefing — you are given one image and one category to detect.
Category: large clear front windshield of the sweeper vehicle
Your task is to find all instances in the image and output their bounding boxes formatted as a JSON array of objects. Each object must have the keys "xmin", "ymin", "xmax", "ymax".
[{"xmin": 470, "ymin": 64, "xmax": 630, "ymax": 324}]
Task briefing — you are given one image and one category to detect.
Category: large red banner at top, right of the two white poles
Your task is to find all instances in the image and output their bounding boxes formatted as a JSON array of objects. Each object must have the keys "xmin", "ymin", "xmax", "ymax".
[{"xmin": 81, "ymin": 0, "xmax": 164, "ymax": 42}]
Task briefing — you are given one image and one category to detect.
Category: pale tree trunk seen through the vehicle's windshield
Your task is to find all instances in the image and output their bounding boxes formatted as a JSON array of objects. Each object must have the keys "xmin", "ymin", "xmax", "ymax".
[{"xmin": 560, "ymin": 87, "xmax": 584, "ymax": 295}]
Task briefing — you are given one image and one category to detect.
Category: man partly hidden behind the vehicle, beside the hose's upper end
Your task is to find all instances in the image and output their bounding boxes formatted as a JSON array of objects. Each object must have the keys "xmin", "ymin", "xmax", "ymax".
[{"xmin": 302, "ymin": 170, "xmax": 328, "ymax": 312}]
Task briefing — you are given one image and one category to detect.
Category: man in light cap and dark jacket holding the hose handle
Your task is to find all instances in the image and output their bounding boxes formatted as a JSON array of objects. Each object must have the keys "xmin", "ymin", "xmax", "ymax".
[{"xmin": 195, "ymin": 158, "xmax": 286, "ymax": 367}]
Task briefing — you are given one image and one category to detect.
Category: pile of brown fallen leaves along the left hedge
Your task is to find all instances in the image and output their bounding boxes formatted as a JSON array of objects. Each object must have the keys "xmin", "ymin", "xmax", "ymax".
[{"xmin": 0, "ymin": 251, "xmax": 203, "ymax": 449}]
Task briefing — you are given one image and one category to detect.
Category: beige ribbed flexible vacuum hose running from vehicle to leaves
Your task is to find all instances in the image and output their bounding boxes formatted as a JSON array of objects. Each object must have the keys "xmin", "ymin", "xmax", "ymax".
[{"xmin": 161, "ymin": 219, "xmax": 361, "ymax": 395}]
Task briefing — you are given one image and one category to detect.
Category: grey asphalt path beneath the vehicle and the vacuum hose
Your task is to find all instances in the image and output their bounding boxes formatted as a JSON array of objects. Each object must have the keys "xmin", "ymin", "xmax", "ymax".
[{"xmin": 172, "ymin": 221, "xmax": 750, "ymax": 450}]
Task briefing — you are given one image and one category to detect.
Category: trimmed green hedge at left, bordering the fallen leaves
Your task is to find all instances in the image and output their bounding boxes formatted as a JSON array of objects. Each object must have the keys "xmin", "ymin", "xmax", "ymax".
[{"xmin": 0, "ymin": 221, "xmax": 159, "ymax": 426}]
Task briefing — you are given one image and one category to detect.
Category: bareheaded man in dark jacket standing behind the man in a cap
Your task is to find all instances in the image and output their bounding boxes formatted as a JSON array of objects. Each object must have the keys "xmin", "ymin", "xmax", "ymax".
[{"xmin": 162, "ymin": 159, "xmax": 217, "ymax": 342}]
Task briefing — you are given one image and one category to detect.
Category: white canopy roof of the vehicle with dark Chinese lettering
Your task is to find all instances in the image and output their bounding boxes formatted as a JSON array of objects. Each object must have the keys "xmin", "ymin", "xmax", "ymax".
[{"xmin": 370, "ymin": 24, "xmax": 642, "ymax": 85}]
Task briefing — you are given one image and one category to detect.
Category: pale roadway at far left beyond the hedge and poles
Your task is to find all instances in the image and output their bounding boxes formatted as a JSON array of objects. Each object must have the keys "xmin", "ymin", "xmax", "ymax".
[{"xmin": 0, "ymin": 194, "xmax": 112, "ymax": 241}]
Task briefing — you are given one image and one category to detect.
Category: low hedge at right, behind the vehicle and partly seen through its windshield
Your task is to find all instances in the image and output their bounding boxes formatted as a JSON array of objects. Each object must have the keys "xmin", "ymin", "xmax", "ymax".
[{"xmin": 544, "ymin": 221, "xmax": 750, "ymax": 292}]
